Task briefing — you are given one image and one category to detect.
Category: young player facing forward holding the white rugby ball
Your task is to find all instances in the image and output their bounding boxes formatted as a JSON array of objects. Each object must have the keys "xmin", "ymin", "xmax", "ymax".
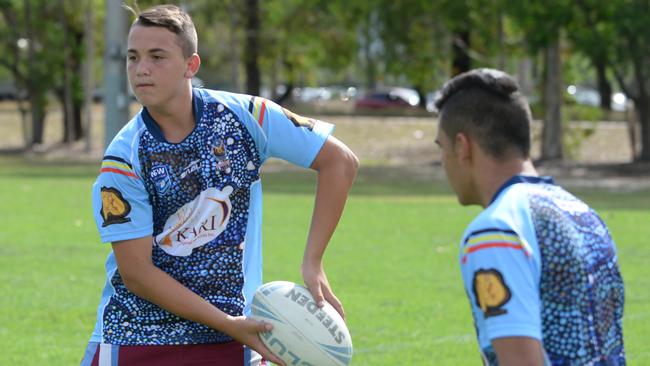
[{"xmin": 82, "ymin": 5, "xmax": 358, "ymax": 366}]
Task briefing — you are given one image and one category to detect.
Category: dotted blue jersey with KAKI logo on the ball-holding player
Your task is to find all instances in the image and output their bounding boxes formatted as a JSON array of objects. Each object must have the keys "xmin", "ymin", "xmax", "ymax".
[{"xmin": 90, "ymin": 89, "xmax": 333, "ymax": 345}]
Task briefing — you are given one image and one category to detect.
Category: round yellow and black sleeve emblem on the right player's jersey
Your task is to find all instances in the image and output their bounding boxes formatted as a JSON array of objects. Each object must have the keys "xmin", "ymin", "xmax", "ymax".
[{"xmin": 472, "ymin": 268, "xmax": 511, "ymax": 318}]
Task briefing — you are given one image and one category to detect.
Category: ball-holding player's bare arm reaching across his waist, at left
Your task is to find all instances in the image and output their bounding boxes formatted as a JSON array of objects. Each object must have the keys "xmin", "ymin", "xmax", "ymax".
[{"xmin": 113, "ymin": 236, "xmax": 283, "ymax": 365}]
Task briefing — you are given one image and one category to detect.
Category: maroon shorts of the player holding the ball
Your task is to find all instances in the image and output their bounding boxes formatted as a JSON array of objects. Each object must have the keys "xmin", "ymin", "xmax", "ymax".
[{"xmin": 81, "ymin": 342, "xmax": 266, "ymax": 366}]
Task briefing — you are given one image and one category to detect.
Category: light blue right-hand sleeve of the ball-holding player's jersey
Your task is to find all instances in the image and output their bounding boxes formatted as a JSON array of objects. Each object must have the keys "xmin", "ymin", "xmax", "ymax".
[{"xmin": 248, "ymin": 97, "xmax": 334, "ymax": 167}]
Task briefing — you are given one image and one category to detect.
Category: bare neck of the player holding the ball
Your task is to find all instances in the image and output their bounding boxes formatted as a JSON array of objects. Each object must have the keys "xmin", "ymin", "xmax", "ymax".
[{"xmin": 147, "ymin": 86, "xmax": 196, "ymax": 143}]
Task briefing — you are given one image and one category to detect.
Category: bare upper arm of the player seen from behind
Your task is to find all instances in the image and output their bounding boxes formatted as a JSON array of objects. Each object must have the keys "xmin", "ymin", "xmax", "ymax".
[{"xmin": 492, "ymin": 337, "xmax": 544, "ymax": 366}]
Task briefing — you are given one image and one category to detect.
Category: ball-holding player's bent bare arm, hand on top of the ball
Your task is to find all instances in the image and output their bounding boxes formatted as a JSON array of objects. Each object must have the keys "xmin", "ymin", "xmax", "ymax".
[{"xmin": 302, "ymin": 136, "xmax": 359, "ymax": 317}]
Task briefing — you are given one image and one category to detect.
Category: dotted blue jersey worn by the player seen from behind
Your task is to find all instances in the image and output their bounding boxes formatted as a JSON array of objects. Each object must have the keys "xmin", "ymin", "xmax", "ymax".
[{"xmin": 459, "ymin": 176, "xmax": 625, "ymax": 365}]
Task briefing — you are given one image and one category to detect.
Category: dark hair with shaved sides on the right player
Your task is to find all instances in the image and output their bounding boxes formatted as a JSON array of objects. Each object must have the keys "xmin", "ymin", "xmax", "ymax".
[{"xmin": 435, "ymin": 68, "xmax": 532, "ymax": 159}]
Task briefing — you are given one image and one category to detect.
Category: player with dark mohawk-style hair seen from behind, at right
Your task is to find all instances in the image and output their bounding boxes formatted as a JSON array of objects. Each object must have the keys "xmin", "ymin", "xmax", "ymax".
[{"xmin": 436, "ymin": 69, "xmax": 625, "ymax": 366}]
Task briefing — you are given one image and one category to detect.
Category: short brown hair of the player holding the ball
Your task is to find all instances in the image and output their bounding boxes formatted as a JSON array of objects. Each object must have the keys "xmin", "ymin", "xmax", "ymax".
[{"xmin": 125, "ymin": 5, "xmax": 199, "ymax": 58}]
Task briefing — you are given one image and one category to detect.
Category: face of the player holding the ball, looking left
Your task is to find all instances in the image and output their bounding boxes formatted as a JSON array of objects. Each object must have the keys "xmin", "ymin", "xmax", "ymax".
[{"xmin": 126, "ymin": 25, "xmax": 198, "ymax": 108}]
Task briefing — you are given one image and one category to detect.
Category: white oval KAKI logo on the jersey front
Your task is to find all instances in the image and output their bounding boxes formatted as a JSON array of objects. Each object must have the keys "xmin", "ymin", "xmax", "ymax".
[{"xmin": 154, "ymin": 187, "xmax": 232, "ymax": 257}]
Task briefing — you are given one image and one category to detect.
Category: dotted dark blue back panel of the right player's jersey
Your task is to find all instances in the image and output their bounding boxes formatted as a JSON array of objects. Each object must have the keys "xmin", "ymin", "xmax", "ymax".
[{"xmin": 526, "ymin": 184, "xmax": 625, "ymax": 365}]
